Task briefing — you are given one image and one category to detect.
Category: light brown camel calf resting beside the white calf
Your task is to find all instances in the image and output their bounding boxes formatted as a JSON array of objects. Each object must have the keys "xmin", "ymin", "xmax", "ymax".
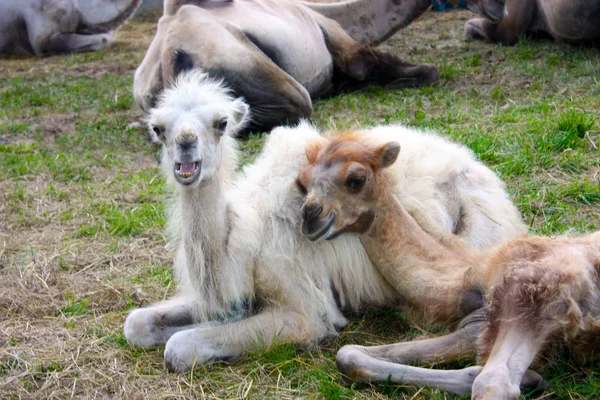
[{"xmin": 299, "ymin": 133, "xmax": 600, "ymax": 399}]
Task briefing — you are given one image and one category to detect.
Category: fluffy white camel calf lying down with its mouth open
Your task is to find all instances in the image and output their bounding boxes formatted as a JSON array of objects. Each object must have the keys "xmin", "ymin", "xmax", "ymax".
[{"xmin": 124, "ymin": 71, "xmax": 525, "ymax": 371}]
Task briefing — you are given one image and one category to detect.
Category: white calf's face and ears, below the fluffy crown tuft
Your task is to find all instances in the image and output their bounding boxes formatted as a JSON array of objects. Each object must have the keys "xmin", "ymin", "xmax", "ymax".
[{"xmin": 149, "ymin": 99, "xmax": 248, "ymax": 186}]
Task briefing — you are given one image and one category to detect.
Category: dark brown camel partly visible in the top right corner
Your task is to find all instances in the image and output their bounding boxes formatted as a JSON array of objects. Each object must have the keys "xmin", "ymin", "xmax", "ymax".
[{"xmin": 465, "ymin": 0, "xmax": 600, "ymax": 44}]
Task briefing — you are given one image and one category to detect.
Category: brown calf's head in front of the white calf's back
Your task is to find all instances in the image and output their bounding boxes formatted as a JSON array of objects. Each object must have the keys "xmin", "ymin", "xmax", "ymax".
[{"xmin": 297, "ymin": 135, "xmax": 400, "ymax": 240}]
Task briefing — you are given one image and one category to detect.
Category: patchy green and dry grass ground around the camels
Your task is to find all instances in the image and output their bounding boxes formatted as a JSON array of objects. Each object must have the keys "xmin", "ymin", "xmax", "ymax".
[{"xmin": 0, "ymin": 7, "xmax": 600, "ymax": 399}]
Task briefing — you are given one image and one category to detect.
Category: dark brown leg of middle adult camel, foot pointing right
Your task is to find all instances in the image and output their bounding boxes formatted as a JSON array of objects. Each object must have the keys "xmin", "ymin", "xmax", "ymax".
[{"xmin": 315, "ymin": 13, "xmax": 439, "ymax": 91}]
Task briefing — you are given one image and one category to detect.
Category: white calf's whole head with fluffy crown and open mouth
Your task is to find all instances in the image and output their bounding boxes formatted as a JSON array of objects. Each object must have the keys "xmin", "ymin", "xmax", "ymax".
[{"xmin": 148, "ymin": 71, "xmax": 248, "ymax": 186}]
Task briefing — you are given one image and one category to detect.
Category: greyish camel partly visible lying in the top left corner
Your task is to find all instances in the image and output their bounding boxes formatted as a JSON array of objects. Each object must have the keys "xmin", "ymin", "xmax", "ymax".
[{"xmin": 0, "ymin": 0, "xmax": 142, "ymax": 57}]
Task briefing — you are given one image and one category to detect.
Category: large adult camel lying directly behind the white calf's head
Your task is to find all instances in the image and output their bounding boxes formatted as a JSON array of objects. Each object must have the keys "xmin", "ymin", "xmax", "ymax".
[{"xmin": 133, "ymin": 0, "xmax": 504, "ymax": 130}]
